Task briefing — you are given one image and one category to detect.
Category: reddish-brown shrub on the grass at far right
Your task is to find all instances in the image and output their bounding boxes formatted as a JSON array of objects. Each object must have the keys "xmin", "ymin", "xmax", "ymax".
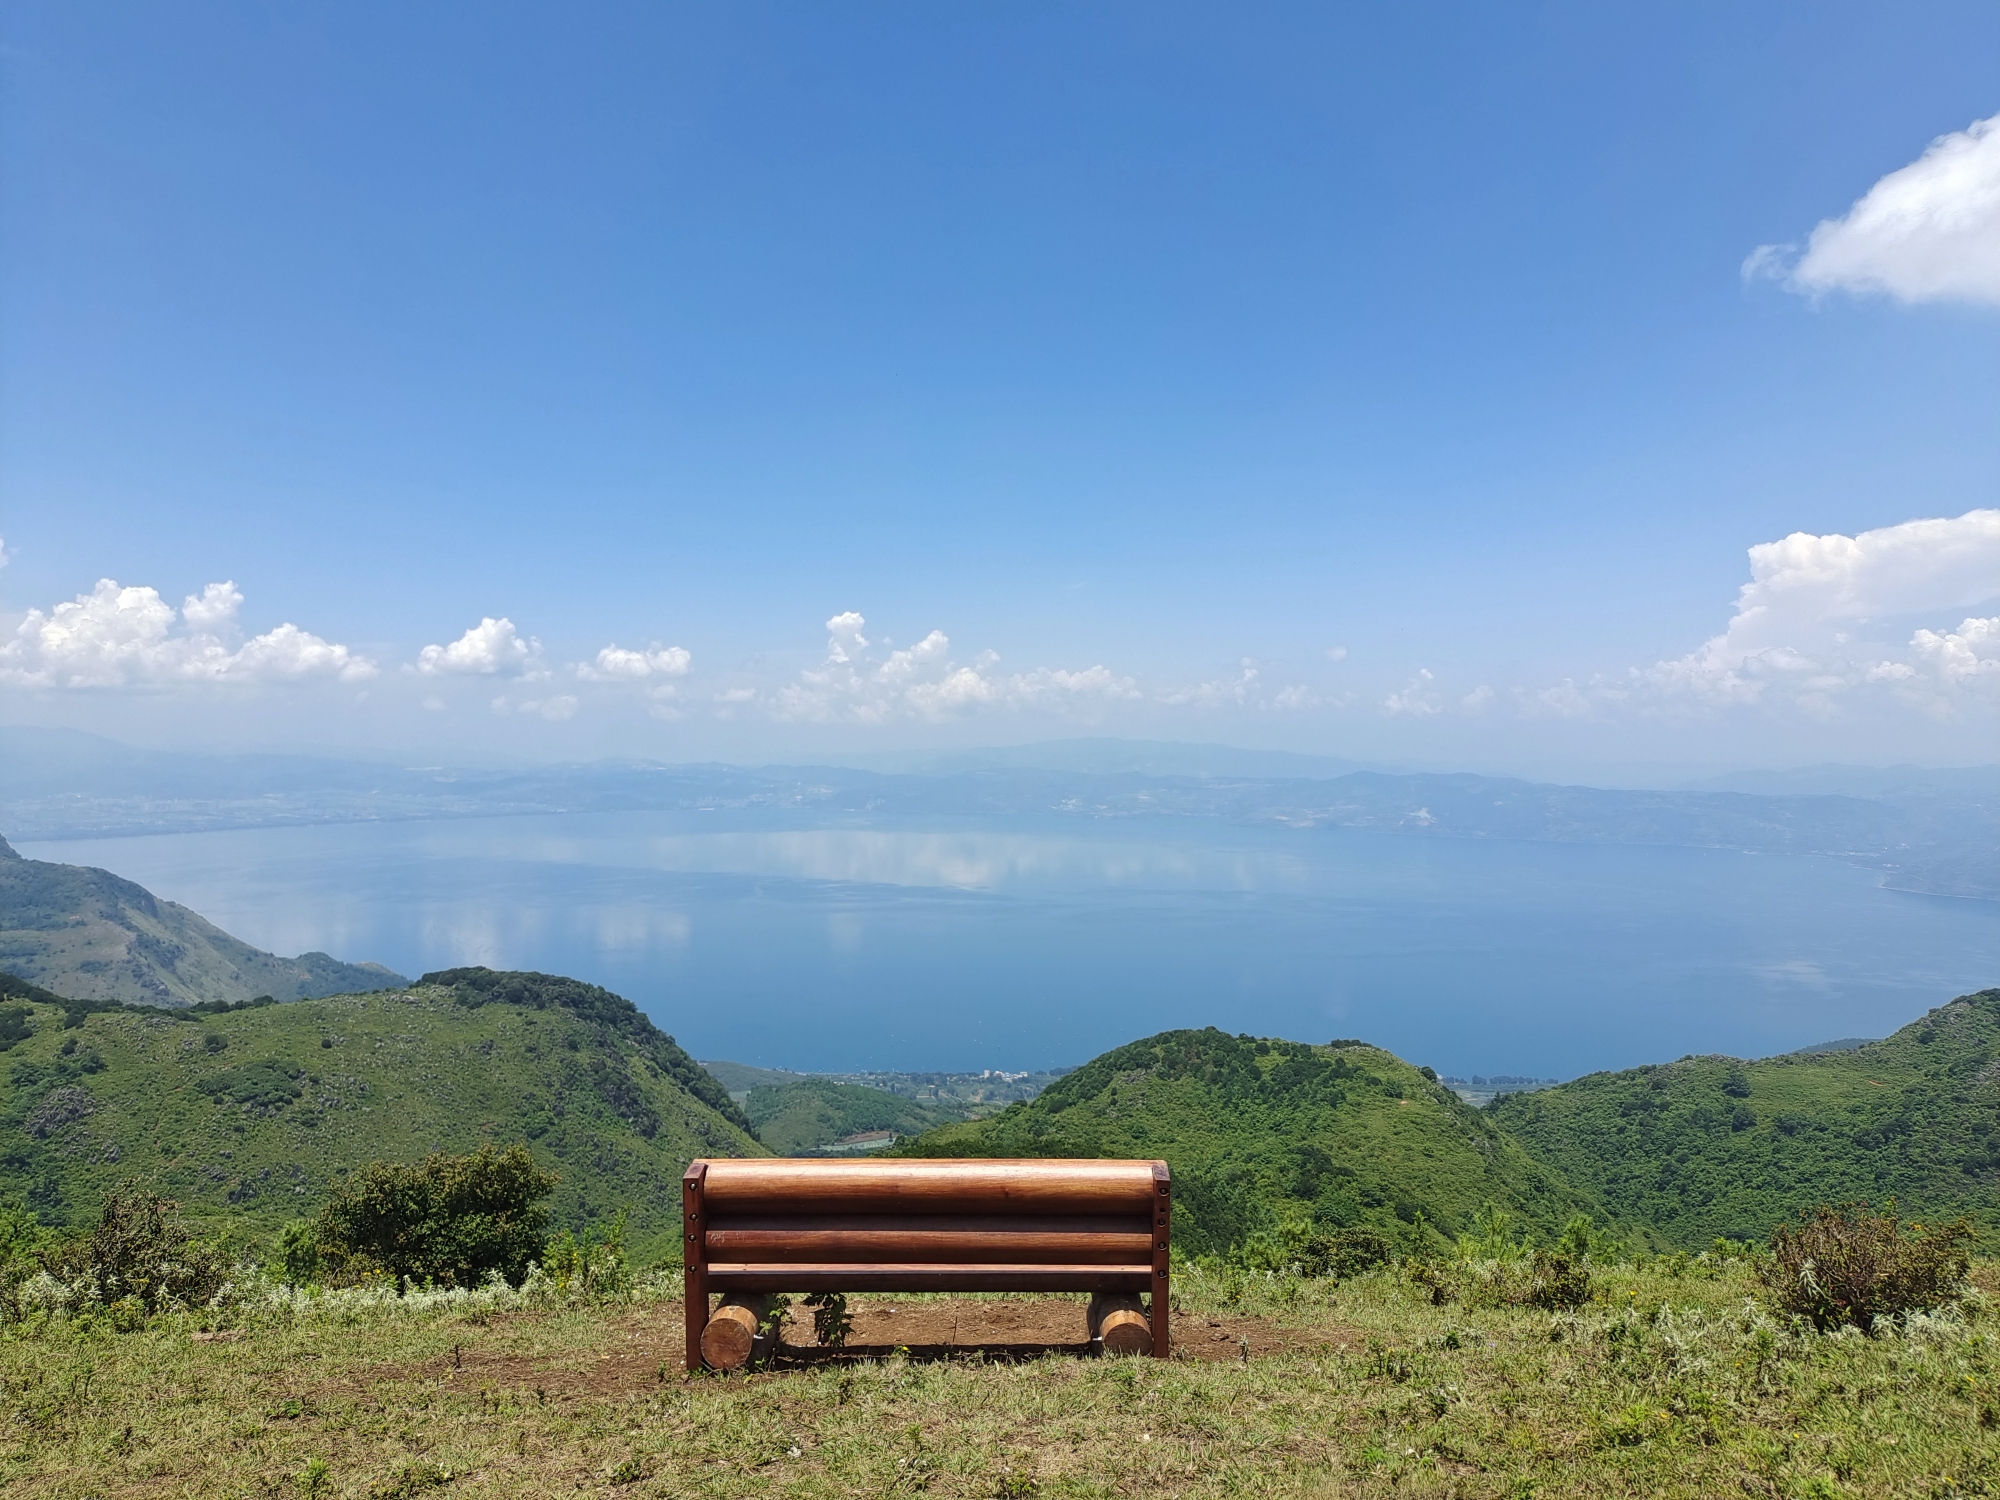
[{"xmin": 1756, "ymin": 1204, "xmax": 1972, "ymax": 1332}]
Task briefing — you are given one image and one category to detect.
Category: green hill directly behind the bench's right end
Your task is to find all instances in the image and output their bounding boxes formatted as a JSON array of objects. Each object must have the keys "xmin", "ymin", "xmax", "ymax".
[{"xmin": 898, "ymin": 1028, "xmax": 1602, "ymax": 1254}]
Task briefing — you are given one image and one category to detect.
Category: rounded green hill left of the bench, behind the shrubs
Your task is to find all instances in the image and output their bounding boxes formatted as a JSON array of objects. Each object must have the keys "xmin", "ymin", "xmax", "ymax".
[{"xmin": 0, "ymin": 968, "xmax": 764, "ymax": 1254}]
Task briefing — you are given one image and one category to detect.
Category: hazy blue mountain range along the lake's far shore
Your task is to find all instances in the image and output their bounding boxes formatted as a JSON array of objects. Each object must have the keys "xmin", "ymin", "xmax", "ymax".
[{"xmin": 0, "ymin": 730, "xmax": 2000, "ymax": 900}]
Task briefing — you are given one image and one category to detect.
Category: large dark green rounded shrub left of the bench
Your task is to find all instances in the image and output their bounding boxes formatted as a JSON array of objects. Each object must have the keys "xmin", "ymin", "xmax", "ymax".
[{"xmin": 316, "ymin": 1146, "xmax": 556, "ymax": 1288}]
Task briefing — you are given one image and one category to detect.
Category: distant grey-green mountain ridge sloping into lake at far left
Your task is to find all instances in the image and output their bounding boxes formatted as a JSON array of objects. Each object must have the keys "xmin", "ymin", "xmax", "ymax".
[{"xmin": 0, "ymin": 838, "xmax": 408, "ymax": 1006}]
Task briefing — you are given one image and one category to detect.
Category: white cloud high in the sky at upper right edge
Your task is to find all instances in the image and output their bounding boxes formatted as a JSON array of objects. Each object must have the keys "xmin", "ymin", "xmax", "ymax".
[{"xmin": 1744, "ymin": 114, "xmax": 2000, "ymax": 306}]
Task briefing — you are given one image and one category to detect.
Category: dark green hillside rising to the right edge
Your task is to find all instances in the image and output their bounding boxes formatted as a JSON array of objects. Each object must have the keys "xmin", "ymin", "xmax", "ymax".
[{"xmin": 1490, "ymin": 990, "xmax": 2000, "ymax": 1248}]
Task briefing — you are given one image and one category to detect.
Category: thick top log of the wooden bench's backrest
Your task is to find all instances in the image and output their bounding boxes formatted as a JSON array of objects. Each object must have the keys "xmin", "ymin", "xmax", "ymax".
[{"xmin": 704, "ymin": 1158, "xmax": 1154, "ymax": 1214}]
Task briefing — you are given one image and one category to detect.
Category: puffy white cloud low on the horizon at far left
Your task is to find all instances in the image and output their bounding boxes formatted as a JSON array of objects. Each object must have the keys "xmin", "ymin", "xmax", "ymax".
[{"xmin": 0, "ymin": 578, "xmax": 378, "ymax": 688}]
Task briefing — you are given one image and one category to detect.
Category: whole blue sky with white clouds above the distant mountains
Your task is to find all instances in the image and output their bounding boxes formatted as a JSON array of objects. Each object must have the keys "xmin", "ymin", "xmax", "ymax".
[{"xmin": 0, "ymin": 4, "xmax": 2000, "ymax": 776}]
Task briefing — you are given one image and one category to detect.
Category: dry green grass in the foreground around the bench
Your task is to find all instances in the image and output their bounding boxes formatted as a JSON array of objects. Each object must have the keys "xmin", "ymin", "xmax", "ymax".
[{"xmin": 0, "ymin": 1260, "xmax": 2000, "ymax": 1500}]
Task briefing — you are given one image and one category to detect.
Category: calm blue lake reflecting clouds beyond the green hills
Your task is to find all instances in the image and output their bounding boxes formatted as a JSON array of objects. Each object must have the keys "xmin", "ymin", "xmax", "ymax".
[{"xmin": 20, "ymin": 812, "xmax": 2000, "ymax": 1078}]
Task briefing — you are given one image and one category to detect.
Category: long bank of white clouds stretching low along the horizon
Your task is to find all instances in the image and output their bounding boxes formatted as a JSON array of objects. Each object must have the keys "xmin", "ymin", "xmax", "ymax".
[{"xmin": 0, "ymin": 508, "xmax": 2000, "ymax": 740}]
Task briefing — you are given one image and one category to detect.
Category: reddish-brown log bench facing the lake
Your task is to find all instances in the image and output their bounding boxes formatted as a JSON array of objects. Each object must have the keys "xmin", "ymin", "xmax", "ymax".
[{"xmin": 680, "ymin": 1158, "xmax": 1172, "ymax": 1372}]
